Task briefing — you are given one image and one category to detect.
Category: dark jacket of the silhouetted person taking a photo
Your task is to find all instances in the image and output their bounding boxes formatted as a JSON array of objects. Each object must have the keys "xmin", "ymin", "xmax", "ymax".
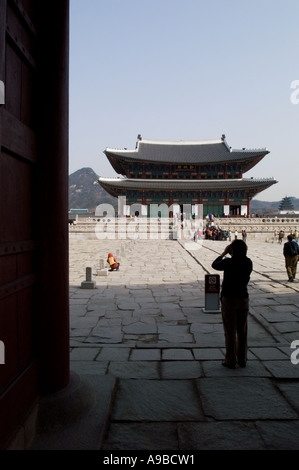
[{"xmin": 212, "ymin": 256, "xmax": 253, "ymax": 299}]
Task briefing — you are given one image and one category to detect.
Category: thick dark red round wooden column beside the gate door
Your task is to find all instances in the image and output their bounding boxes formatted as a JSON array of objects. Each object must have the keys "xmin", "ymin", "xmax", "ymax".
[{"xmin": 36, "ymin": 0, "xmax": 69, "ymax": 394}]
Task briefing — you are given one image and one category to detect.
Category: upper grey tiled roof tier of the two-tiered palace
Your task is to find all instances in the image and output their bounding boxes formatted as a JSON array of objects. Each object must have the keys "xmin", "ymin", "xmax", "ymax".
[{"xmin": 104, "ymin": 135, "xmax": 269, "ymax": 174}]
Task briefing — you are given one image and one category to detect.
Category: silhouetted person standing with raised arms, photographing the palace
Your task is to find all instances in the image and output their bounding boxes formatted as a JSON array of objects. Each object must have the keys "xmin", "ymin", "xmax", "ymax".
[{"xmin": 212, "ymin": 240, "xmax": 253, "ymax": 369}]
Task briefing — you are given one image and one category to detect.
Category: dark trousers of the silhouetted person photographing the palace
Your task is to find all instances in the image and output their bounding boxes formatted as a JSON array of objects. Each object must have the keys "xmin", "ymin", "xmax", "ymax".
[{"xmin": 221, "ymin": 297, "xmax": 249, "ymax": 366}]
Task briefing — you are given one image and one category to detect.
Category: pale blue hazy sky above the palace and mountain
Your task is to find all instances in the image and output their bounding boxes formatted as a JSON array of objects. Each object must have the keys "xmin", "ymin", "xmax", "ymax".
[{"xmin": 69, "ymin": 0, "xmax": 299, "ymax": 201}]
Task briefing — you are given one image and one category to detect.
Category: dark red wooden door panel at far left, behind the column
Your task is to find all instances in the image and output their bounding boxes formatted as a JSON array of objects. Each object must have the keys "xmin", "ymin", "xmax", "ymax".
[{"xmin": 0, "ymin": 0, "xmax": 38, "ymax": 448}]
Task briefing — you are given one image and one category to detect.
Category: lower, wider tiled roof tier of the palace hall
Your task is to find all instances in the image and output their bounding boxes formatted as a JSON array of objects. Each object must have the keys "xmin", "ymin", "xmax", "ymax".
[{"xmin": 98, "ymin": 178, "xmax": 277, "ymax": 191}]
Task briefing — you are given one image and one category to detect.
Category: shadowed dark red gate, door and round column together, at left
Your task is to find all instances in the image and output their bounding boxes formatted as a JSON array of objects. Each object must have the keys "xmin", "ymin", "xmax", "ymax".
[{"xmin": 0, "ymin": 0, "xmax": 69, "ymax": 448}]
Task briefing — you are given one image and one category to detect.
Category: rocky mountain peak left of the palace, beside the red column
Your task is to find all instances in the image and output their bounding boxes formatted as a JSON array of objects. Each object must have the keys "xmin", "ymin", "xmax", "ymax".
[{"xmin": 69, "ymin": 168, "xmax": 117, "ymax": 212}]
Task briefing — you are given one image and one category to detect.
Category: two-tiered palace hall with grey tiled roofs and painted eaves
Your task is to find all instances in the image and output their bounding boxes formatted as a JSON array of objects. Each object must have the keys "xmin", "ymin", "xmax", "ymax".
[{"xmin": 98, "ymin": 135, "xmax": 277, "ymax": 217}]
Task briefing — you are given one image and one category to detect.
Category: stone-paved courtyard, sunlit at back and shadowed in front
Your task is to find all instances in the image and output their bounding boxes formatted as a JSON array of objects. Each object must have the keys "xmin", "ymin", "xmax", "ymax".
[{"xmin": 31, "ymin": 239, "xmax": 299, "ymax": 451}]
